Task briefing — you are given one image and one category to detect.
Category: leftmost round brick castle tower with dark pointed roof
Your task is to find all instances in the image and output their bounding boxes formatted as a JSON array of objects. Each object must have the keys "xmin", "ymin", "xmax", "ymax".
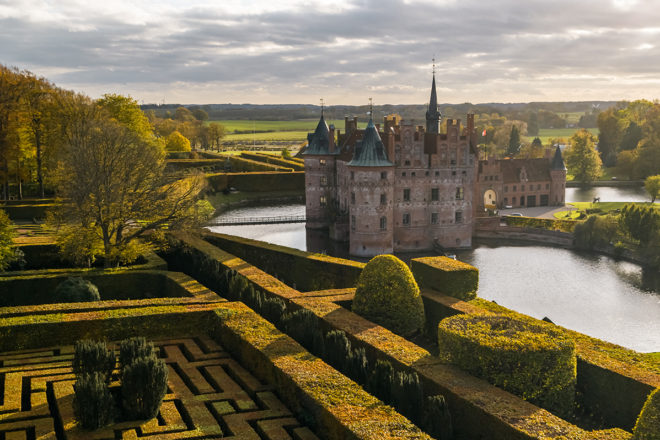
[{"xmin": 303, "ymin": 110, "xmax": 337, "ymax": 229}]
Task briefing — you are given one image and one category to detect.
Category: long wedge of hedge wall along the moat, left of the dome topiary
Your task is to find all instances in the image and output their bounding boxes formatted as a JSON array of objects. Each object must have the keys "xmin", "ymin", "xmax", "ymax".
[{"xmin": 203, "ymin": 232, "xmax": 364, "ymax": 292}]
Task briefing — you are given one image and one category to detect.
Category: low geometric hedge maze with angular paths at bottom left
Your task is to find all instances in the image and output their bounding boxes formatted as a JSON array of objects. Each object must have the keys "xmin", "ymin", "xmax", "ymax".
[{"xmin": 0, "ymin": 335, "xmax": 317, "ymax": 440}]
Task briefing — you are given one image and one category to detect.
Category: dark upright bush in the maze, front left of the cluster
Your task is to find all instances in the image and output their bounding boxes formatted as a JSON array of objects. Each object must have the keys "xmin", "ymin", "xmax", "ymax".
[{"xmin": 73, "ymin": 372, "xmax": 116, "ymax": 430}]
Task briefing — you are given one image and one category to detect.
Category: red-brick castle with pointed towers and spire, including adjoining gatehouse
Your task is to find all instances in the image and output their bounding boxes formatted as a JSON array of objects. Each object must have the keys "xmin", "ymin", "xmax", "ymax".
[{"xmin": 303, "ymin": 74, "xmax": 566, "ymax": 257}]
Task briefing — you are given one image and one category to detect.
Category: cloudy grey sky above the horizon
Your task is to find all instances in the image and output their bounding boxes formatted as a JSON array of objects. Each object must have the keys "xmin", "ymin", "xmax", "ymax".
[{"xmin": 0, "ymin": 0, "xmax": 660, "ymax": 105}]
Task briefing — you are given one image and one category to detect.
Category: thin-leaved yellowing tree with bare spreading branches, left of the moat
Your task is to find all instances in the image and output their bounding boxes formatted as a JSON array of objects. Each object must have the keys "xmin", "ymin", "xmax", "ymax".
[{"xmin": 52, "ymin": 94, "xmax": 203, "ymax": 266}]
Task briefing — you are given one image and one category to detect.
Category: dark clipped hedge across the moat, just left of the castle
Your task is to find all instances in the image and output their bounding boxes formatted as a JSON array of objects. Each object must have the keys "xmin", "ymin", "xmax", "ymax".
[{"xmin": 206, "ymin": 171, "xmax": 305, "ymax": 192}]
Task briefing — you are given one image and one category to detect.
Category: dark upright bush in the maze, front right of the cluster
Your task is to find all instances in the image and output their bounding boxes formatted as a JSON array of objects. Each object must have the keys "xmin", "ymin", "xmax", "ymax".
[{"xmin": 121, "ymin": 357, "xmax": 167, "ymax": 420}]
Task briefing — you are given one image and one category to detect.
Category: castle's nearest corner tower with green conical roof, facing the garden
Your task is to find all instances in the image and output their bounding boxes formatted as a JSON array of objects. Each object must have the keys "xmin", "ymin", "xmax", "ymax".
[{"xmin": 347, "ymin": 119, "xmax": 394, "ymax": 257}]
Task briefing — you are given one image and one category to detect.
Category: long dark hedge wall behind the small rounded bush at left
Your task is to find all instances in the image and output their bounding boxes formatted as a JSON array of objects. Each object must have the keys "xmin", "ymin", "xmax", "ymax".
[{"xmin": 0, "ymin": 270, "xmax": 202, "ymax": 307}]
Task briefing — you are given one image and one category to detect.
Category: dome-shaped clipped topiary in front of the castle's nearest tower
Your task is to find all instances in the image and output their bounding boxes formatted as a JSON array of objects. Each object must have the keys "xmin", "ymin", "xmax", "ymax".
[{"xmin": 353, "ymin": 255, "xmax": 424, "ymax": 336}]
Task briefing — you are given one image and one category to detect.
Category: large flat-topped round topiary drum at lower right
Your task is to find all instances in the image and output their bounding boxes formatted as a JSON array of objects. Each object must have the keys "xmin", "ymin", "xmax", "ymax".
[{"xmin": 438, "ymin": 314, "xmax": 577, "ymax": 417}]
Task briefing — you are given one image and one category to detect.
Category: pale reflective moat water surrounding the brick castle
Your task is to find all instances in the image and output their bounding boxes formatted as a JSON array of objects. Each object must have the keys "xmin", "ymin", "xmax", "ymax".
[{"xmin": 210, "ymin": 188, "xmax": 660, "ymax": 352}]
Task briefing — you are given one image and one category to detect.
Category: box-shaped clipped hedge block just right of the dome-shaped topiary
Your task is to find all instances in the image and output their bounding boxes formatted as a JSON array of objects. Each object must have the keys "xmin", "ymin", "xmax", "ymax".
[{"xmin": 411, "ymin": 257, "xmax": 479, "ymax": 301}]
